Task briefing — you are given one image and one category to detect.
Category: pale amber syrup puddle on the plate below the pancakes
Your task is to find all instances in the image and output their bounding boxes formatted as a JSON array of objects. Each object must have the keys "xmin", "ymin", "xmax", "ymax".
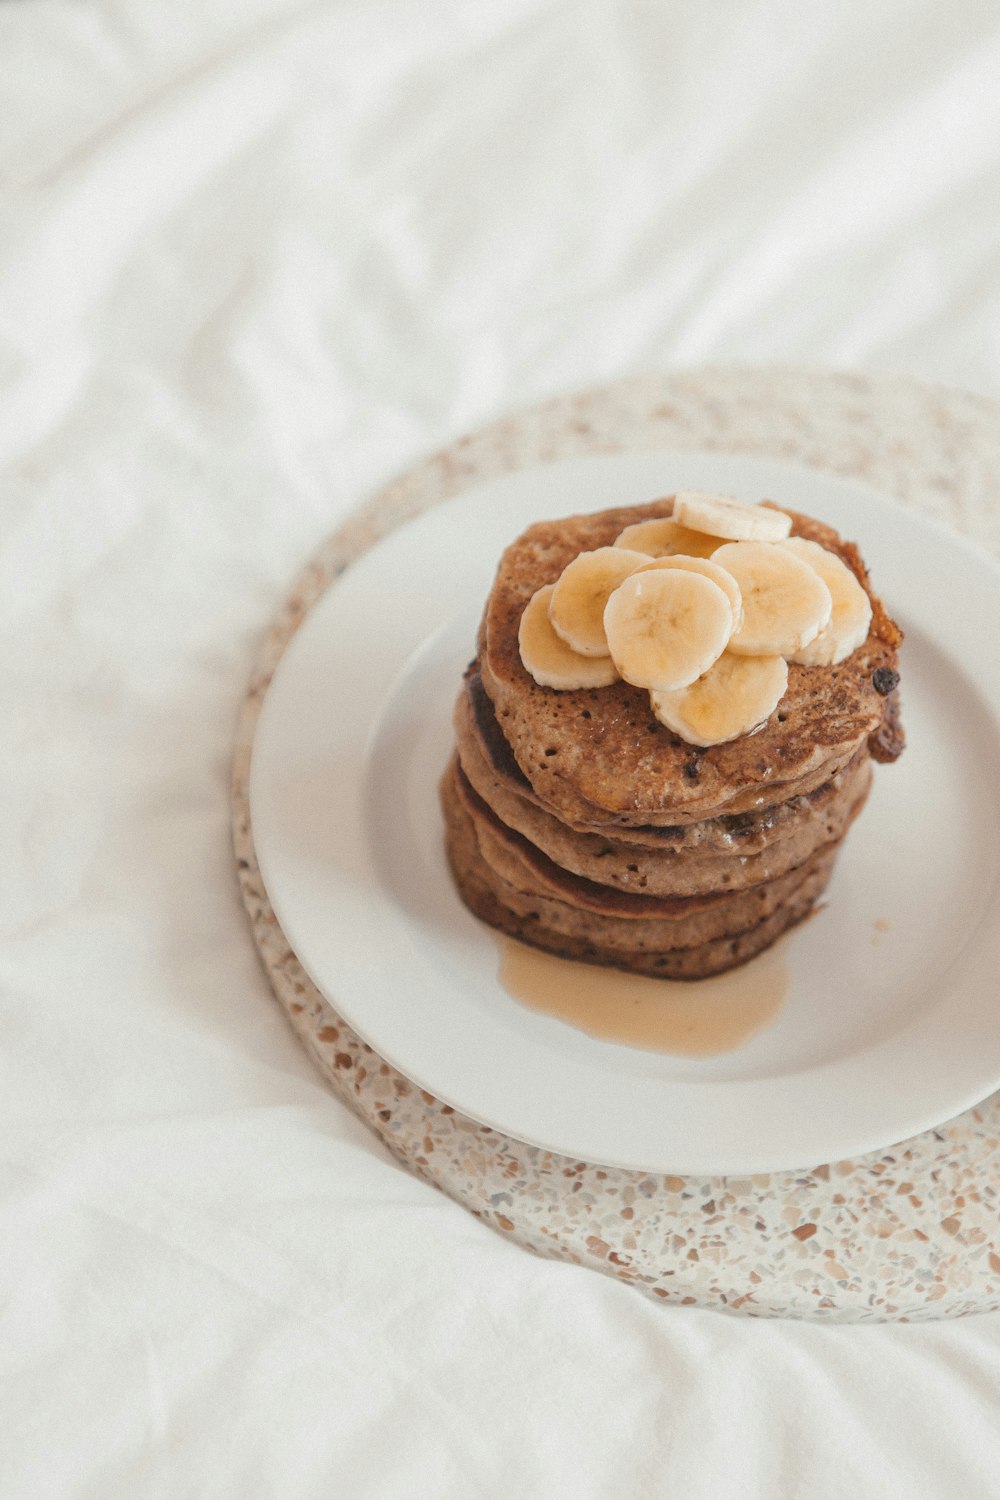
[{"xmin": 498, "ymin": 938, "xmax": 789, "ymax": 1058}]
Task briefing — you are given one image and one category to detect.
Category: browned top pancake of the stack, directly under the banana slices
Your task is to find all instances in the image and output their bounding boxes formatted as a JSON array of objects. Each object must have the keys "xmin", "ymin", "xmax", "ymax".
[{"xmin": 480, "ymin": 498, "xmax": 903, "ymax": 827}]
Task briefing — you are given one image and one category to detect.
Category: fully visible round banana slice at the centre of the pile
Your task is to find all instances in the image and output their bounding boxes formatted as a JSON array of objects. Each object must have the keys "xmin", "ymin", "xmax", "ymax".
[{"xmin": 604, "ymin": 569, "xmax": 733, "ymax": 690}]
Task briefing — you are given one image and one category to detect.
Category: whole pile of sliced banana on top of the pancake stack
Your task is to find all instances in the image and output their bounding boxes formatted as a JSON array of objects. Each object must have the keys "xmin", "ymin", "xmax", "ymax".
[{"xmin": 517, "ymin": 491, "xmax": 871, "ymax": 747}]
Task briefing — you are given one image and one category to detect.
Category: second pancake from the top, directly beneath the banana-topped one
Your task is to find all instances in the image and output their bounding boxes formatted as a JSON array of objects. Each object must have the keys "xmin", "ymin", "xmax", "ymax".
[{"xmin": 454, "ymin": 674, "xmax": 871, "ymax": 896}]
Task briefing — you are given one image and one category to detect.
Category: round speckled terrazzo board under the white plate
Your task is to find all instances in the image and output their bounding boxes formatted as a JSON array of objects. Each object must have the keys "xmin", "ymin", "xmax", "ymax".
[{"xmin": 232, "ymin": 369, "xmax": 1000, "ymax": 1322}]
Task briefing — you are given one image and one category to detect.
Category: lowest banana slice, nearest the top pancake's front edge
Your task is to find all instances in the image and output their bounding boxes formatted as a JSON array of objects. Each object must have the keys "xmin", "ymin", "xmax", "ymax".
[{"xmin": 649, "ymin": 651, "xmax": 789, "ymax": 746}]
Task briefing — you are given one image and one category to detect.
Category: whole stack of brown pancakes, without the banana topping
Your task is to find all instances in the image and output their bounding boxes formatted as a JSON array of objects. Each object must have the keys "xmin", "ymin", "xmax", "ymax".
[{"xmin": 442, "ymin": 500, "xmax": 903, "ymax": 980}]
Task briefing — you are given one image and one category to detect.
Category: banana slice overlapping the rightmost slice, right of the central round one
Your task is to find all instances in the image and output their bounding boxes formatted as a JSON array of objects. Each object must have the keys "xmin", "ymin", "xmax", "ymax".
[{"xmin": 714, "ymin": 542, "xmax": 834, "ymax": 657}]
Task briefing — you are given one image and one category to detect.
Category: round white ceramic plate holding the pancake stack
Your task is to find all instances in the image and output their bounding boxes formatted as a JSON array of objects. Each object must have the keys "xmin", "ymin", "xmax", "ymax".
[{"xmin": 250, "ymin": 453, "xmax": 1000, "ymax": 1175}]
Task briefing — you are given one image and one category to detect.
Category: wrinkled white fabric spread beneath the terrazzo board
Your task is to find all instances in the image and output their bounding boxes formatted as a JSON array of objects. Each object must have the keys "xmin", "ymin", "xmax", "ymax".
[{"xmin": 0, "ymin": 0, "xmax": 1000, "ymax": 1500}]
